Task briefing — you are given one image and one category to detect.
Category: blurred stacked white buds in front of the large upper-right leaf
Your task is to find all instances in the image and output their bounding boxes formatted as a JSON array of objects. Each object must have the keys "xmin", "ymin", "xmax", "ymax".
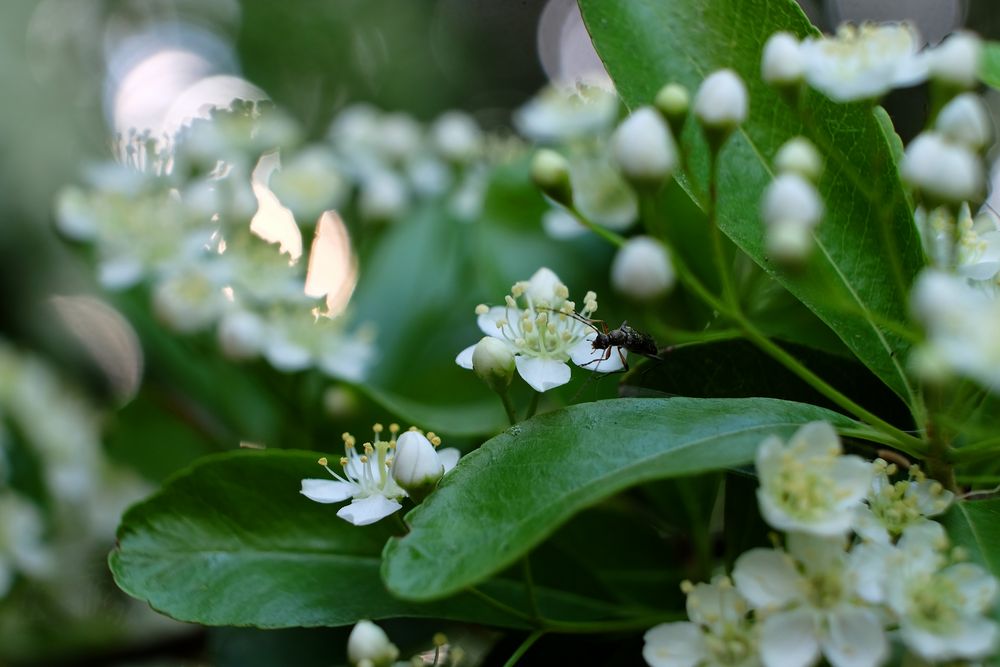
[{"xmin": 761, "ymin": 137, "xmax": 823, "ymax": 265}]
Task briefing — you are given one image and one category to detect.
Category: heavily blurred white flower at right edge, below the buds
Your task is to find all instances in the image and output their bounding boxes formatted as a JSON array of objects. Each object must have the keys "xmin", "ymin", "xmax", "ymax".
[{"xmin": 911, "ymin": 269, "xmax": 1000, "ymax": 390}]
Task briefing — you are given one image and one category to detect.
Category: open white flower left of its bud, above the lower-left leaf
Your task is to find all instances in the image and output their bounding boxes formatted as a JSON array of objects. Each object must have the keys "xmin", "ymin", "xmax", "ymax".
[{"xmin": 300, "ymin": 424, "xmax": 406, "ymax": 526}]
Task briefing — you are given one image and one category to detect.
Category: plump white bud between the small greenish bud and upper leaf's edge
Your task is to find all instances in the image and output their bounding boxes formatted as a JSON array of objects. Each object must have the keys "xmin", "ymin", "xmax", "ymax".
[{"xmin": 611, "ymin": 107, "xmax": 677, "ymax": 185}]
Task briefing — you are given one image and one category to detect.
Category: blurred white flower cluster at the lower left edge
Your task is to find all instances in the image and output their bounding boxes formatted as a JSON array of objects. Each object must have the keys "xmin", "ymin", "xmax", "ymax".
[{"xmin": 0, "ymin": 340, "xmax": 171, "ymax": 643}]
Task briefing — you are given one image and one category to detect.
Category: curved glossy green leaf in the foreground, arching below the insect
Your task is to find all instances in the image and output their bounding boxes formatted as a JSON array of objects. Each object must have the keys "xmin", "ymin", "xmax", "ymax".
[{"xmin": 382, "ymin": 398, "xmax": 854, "ymax": 600}]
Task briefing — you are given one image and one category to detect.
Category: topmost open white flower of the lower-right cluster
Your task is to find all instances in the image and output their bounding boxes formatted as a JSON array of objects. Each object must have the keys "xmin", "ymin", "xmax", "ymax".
[{"xmin": 756, "ymin": 422, "xmax": 872, "ymax": 537}]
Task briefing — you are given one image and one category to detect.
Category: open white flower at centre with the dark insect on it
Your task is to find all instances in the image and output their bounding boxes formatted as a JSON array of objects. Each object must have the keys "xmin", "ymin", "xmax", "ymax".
[{"xmin": 455, "ymin": 268, "xmax": 624, "ymax": 391}]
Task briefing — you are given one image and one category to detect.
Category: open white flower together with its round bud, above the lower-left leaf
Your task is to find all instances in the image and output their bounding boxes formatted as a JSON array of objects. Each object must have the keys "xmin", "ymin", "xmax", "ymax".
[{"xmin": 300, "ymin": 424, "xmax": 459, "ymax": 526}]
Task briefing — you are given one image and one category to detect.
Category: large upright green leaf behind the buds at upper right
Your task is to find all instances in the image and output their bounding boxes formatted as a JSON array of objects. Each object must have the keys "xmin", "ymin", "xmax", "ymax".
[{"xmin": 580, "ymin": 0, "xmax": 923, "ymax": 403}]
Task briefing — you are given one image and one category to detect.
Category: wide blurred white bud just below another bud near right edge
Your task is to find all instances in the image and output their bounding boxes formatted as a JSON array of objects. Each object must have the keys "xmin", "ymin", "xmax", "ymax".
[{"xmin": 900, "ymin": 132, "xmax": 983, "ymax": 204}]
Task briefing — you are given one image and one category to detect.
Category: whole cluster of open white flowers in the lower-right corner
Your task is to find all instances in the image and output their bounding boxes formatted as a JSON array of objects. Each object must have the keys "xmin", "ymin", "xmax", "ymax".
[{"xmin": 643, "ymin": 422, "xmax": 1000, "ymax": 667}]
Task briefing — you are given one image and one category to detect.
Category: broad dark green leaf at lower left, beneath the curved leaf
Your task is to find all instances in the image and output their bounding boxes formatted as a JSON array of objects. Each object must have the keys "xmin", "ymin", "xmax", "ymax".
[{"xmin": 109, "ymin": 450, "xmax": 610, "ymax": 628}]
